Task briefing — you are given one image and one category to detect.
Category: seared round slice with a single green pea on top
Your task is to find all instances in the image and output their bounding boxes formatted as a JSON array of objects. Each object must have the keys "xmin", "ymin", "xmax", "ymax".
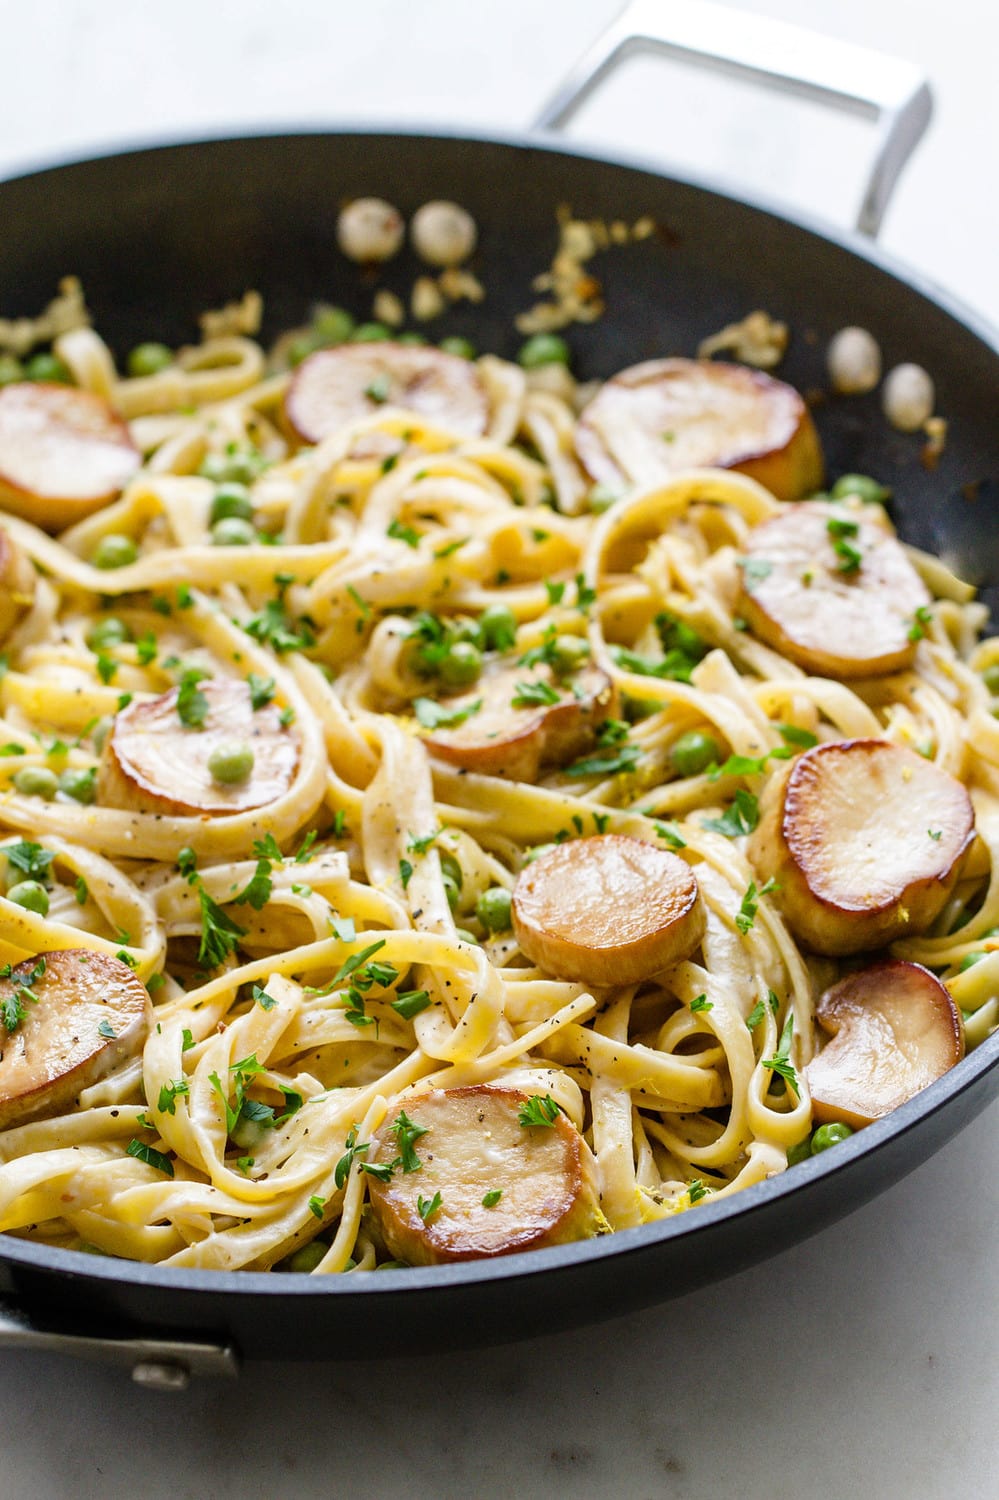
[{"xmin": 98, "ymin": 678, "xmax": 299, "ymax": 818}]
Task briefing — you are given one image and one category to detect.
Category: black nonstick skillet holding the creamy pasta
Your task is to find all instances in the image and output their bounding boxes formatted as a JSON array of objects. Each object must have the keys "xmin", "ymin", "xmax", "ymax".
[{"xmin": 0, "ymin": 8, "xmax": 999, "ymax": 1386}]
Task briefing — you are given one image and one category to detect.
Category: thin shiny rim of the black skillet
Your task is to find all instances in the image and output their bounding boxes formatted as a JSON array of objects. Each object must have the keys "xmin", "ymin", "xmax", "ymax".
[{"xmin": 0, "ymin": 122, "xmax": 999, "ymax": 1302}]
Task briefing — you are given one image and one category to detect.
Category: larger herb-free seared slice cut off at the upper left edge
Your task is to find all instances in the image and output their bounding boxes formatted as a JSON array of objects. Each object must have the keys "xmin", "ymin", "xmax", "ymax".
[{"xmin": 0, "ymin": 381, "xmax": 143, "ymax": 531}]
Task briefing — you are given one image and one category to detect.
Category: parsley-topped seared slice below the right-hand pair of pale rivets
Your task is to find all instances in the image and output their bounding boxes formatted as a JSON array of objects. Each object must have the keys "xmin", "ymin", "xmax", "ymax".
[{"xmin": 737, "ymin": 501, "xmax": 930, "ymax": 678}]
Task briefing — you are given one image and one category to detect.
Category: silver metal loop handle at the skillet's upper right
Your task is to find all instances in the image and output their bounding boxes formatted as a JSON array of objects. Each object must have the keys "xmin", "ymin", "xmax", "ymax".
[{"xmin": 534, "ymin": 0, "xmax": 933, "ymax": 239}]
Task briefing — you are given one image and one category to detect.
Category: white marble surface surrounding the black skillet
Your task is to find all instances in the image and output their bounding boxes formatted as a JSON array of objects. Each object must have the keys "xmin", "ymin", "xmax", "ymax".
[{"xmin": 0, "ymin": 0, "xmax": 999, "ymax": 1500}]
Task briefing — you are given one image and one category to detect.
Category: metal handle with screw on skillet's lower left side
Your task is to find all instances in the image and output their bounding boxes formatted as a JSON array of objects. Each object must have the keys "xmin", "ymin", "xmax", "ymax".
[{"xmin": 0, "ymin": 1302, "xmax": 240, "ymax": 1391}]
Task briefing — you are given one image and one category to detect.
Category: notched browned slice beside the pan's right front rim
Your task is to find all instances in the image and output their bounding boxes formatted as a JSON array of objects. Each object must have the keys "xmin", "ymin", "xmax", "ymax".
[{"xmin": 806, "ymin": 959, "xmax": 965, "ymax": 1128}]
